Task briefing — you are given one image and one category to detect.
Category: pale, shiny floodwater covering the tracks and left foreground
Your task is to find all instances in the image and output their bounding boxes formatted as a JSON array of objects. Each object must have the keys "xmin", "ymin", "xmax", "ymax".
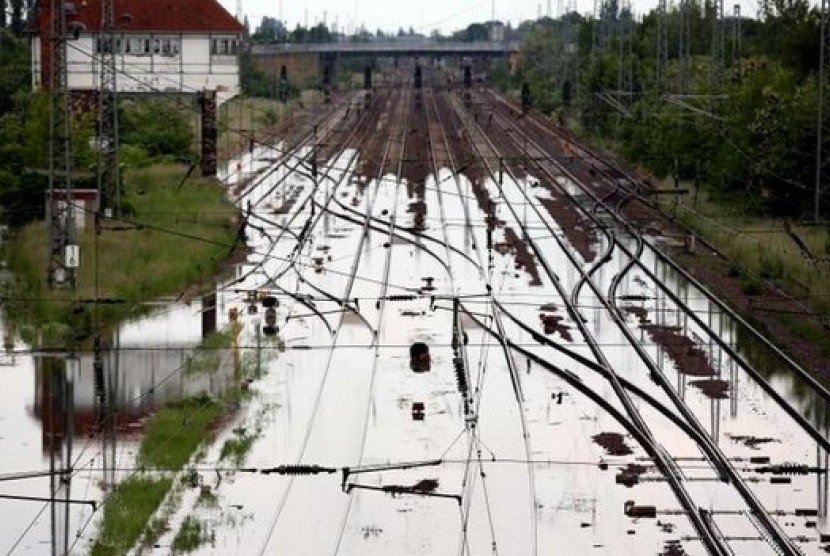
[{"xmin": 0, "ymin": 134, "xmax": 830, "ymax": 556}]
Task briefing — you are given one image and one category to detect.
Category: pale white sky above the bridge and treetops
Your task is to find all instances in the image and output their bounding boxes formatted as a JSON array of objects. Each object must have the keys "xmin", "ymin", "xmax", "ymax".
[{"xmin": 219, "ymin": 0, "xmax": 772, "ymax": 35}]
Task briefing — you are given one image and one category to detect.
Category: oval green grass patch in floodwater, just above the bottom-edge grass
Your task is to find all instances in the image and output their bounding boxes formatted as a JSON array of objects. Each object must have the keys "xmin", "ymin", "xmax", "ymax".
[{"xmin": 138, "ymin": 396, "xmax": 222, "ymax": 471}]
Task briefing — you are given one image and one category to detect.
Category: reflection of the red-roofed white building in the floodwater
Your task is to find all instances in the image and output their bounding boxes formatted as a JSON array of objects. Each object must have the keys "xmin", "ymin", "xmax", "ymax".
[{"xmin": 27, "ymin": 305, "xmax": 235, "ymax": 554}]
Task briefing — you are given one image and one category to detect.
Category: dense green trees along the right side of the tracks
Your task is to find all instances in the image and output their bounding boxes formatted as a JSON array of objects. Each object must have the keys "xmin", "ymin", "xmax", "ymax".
[{"xmin": 516, "ymin": 0, "xmax": 830, "ymax": 217}]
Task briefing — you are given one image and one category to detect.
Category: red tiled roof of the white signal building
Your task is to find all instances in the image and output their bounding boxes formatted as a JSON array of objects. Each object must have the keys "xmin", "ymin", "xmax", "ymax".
[{"xmin": 38, "ymin": 0, "xmax": 243, "ymax": 34}]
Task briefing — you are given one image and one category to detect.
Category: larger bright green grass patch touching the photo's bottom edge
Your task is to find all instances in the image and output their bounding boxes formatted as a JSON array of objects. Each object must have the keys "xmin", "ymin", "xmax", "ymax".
[{"xmin": 91, "ymin": 476, "xmax": 171, "ymax": 556}]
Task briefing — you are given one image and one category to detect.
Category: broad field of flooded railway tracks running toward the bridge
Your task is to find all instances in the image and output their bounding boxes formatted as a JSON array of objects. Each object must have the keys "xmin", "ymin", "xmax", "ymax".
[{"xmin": 182, "ymin": 82, "xmax": 828, "ymax": 556}]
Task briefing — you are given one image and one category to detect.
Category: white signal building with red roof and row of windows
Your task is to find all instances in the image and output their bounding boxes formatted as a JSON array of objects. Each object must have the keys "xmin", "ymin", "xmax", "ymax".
[{"xmin": 32, "ymin": 0, "xmax": 244, "ymax": 103}]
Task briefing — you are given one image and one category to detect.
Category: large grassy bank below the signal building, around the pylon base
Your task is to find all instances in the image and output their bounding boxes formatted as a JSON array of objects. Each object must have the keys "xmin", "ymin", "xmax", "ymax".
[{"xmin": 7, "ymin": 164, "xmax": 237, "ymax": 345}]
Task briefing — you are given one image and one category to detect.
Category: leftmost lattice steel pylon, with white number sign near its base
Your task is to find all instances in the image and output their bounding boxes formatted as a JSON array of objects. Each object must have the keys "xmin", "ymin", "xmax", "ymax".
[{"xmin": 44, "ymin": 0, "xmax": 75, "ymax": 288}]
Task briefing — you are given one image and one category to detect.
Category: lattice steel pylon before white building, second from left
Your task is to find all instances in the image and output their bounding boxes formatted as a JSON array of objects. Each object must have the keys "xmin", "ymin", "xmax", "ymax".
[{"xmin": 98, "ymin": 0, "xmax": 121, "ymax": 217}]
